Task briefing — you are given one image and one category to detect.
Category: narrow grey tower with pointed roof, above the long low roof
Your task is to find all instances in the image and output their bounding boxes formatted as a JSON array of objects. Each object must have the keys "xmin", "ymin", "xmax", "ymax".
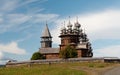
[{"xmin": 41, "ymin": 23, "xmax": 52, "ymax": 48}]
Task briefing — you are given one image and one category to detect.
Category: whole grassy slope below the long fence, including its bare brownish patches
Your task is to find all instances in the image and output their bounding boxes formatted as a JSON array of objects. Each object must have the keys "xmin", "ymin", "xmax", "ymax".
[{"xmin": 0, "ymin": 62, "xmax": 118, "ymax": 75}]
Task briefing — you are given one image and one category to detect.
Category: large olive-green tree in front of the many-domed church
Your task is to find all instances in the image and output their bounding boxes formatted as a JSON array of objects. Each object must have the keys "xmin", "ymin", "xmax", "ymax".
[{"xmin": 60, "ymin": 45, "xmax": 77, "ymax": 59}]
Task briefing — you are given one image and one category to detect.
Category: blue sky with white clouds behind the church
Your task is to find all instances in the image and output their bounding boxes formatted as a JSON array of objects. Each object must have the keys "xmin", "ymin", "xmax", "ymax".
[{"xmin": 0, "ymin": 0, "xmax": 120, "ymax": 63}]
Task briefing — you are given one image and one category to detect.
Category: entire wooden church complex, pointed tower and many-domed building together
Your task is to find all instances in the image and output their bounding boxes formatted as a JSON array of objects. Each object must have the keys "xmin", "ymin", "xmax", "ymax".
[{"xmin": 39, "ymin": 17, "xmax": 93, "ymax": 59}]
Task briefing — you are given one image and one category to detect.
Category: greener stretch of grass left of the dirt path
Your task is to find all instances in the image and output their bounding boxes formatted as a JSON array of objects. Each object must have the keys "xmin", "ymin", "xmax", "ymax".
[{"xmin": 0, "ymin": 64, "xmax": 87, "ymax": 75}]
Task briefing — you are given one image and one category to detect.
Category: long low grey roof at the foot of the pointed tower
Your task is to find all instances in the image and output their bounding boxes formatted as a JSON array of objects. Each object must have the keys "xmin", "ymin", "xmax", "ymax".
[{"xmin": 39, "ymin": 48, "xmax": 60, "ymax": 54}]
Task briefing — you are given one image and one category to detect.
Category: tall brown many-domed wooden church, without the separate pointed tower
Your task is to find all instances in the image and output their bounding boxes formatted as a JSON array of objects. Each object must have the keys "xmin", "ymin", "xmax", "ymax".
[{"xmin": 59, "ymin": 20, "xmax": 93, "ymax": 57}]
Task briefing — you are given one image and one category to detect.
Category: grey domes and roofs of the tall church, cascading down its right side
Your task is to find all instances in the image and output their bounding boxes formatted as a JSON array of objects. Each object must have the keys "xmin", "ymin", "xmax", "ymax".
[{"xmin": 61, "ymin": 20, "xmax": 93, "ymax": 57}]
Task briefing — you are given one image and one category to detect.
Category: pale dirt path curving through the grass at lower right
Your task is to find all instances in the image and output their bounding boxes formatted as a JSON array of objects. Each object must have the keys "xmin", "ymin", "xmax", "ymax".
[{"xmin": 70, "ymin": 64, "xmax": 120, "ymax": 75}]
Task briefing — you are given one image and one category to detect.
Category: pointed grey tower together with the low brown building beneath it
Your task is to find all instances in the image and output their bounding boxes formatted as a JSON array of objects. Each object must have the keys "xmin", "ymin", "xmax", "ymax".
[{"xmin": 39, "ymin": 23, "xmax": 59, "ymax": 59}]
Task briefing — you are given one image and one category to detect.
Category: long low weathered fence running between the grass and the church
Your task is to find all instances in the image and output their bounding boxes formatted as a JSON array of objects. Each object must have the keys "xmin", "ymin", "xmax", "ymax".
[{"xmin": 6, "ymin": 58, "xmax": 120, "ymax": 67}]
